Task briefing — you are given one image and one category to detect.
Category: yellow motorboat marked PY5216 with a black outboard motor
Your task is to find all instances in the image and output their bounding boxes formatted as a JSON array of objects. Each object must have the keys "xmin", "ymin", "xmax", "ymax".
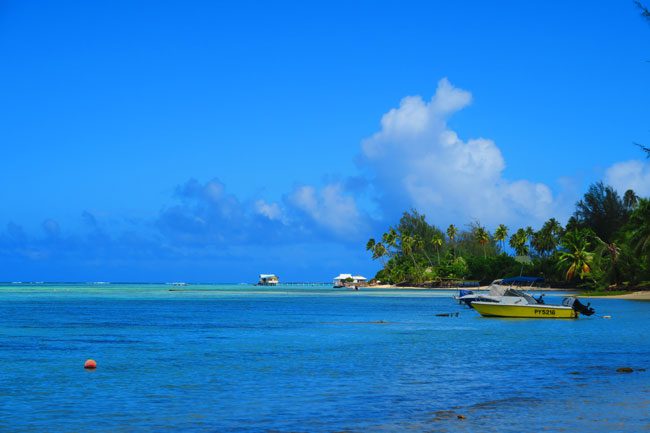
[{"xmin": 472, "ymin": 292, "xmax": 595, "ymax": 319}]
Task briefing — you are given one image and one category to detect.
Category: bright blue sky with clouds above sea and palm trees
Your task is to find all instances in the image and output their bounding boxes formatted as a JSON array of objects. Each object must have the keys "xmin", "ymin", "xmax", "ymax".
[{"xmin": 0, "ymin": 1, "xmax": 650, "ymax": 282}]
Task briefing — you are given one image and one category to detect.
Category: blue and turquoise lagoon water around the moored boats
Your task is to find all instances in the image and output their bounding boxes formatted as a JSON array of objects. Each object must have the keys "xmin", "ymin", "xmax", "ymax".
[{"xmin": 0, "ymin": 285, "xmax": 650, "ymax": 432}]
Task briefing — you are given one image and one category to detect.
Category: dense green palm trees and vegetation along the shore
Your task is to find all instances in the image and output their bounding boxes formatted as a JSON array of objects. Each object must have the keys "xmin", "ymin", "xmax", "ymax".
[{"xmin": 366, "ymin": 182, "xmax": 650, "ymax": 293}]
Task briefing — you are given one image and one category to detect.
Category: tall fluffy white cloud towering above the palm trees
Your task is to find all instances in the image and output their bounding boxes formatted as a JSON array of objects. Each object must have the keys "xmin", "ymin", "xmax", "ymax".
[{"xmin": 361, "ymin": 78, "xmax": 557, "ymax": 225}]
